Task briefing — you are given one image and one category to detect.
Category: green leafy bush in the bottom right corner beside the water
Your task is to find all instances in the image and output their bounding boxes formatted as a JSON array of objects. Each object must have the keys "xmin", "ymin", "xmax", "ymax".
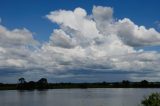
[{"xmin": 141, "ymin": 93, "xmax": 160, "ymax": 106}]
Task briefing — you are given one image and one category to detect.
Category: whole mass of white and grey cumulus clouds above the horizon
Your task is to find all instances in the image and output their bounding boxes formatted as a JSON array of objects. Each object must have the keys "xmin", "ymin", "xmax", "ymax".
[{"xmin": 0, "ymin": 6, "xmax": 160, "ymax": 80}]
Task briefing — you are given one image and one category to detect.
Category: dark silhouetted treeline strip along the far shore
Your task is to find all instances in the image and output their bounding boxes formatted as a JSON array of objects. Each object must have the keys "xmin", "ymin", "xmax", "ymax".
[{"xmin": 0, "ymin": 78, "xmax": 160, "ymax": 90}]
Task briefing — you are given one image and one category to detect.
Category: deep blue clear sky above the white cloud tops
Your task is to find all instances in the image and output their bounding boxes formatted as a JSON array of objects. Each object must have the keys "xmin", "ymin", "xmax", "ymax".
[{"xmin": 0, "ymin": 0, "xmax": 160, "ymax": 41}]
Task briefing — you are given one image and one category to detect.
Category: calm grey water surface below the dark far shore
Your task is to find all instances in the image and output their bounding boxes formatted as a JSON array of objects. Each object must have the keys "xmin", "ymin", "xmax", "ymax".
[{"xmin": 0, "ymin": 88, "xmax": 160, "ymax": 106}]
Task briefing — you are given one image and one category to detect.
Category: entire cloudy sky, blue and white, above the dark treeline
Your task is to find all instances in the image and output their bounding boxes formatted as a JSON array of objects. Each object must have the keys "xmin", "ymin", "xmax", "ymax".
[{"xmin": 0, "ymin": 0, "xmax": 160, "ymax": 83}]
